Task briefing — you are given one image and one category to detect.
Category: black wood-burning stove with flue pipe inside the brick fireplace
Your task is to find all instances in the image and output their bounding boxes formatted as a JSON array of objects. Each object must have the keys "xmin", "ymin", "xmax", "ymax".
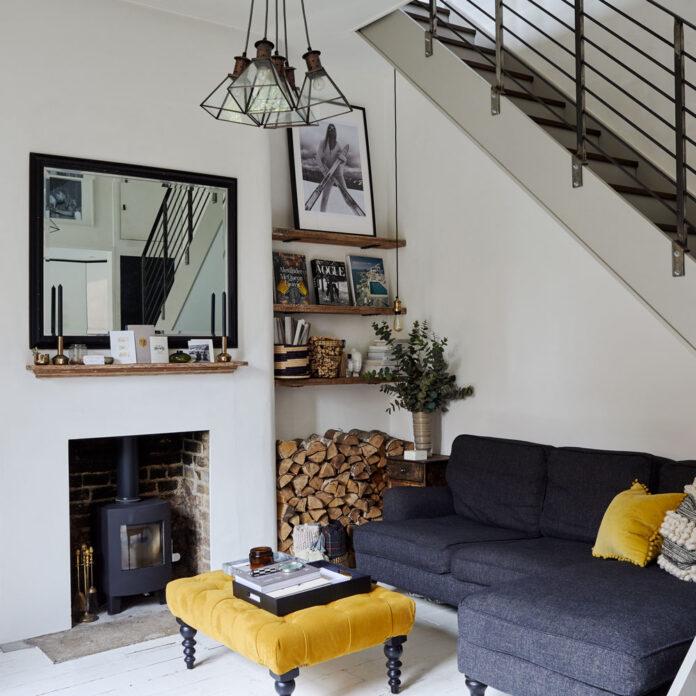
[{"xmin": 96, "ymin": 437, "xmax": 172, "ymax": 614}]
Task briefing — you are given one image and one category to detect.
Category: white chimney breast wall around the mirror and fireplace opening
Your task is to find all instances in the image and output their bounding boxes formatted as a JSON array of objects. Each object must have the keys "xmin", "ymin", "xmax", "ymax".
[{"xmin": 0, "ymin": 0, "xmax": 275, "ymax": 643}]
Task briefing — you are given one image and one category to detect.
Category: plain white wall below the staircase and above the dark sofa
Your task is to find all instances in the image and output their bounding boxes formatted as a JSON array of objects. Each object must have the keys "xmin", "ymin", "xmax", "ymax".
[{"xmin": 391, "ymin": 79, "xmax": 696, "ymax": 458}]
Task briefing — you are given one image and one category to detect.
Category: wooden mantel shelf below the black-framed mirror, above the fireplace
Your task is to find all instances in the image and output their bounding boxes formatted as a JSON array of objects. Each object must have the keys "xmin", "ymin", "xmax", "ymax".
[{"xmin": 27, "ymin": 361, "xmax": 249, "ymax": 379}]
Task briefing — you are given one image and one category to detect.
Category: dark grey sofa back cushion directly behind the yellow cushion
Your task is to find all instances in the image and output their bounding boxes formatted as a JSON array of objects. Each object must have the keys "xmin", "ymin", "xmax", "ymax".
[{"xmin": 541, "ymin": 447, "xmax": 652, "ymax": 542}]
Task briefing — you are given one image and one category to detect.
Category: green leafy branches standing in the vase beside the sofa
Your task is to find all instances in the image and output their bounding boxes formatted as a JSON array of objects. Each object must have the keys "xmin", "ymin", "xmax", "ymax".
[{"xmin": 365, "ymin": 321, "xmax": 474, "ymax": 413}]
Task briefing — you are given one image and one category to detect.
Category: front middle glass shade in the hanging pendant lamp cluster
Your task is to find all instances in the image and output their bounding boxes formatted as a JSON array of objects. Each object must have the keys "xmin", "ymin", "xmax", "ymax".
[{"xmin": 228, "ymin": 40, "xmax": 295, "ymax": 121}]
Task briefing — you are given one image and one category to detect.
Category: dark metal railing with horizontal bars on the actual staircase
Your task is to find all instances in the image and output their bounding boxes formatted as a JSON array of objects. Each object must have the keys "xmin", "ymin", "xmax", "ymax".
[{"xmin": 426, "ymin": 0, "xmax": 696, "ymax": 277}]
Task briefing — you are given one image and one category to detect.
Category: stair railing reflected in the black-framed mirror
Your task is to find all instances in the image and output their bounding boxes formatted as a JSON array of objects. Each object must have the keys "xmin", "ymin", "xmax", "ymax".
[{"xmin": 140, "ymin": 184, "xmax": 212, "ymax": 324}]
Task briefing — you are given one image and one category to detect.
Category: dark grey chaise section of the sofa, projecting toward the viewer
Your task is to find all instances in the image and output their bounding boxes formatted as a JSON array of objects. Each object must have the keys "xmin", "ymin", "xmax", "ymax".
[{"xmin": 459, "ymin": 559, "xmax": 696, "ymax": 696}]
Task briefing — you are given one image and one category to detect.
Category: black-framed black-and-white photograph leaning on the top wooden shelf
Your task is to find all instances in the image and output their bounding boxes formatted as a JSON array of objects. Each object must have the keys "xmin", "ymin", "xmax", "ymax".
[{"xmin": 288, "ymin": 106, "xmax": 376, "ymax": 236}]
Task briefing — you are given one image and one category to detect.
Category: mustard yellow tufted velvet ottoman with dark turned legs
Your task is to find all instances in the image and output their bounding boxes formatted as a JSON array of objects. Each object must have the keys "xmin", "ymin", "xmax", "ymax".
[{"xmin": 167, "ymin": 570, "xmax": 416, "ymax": 696}]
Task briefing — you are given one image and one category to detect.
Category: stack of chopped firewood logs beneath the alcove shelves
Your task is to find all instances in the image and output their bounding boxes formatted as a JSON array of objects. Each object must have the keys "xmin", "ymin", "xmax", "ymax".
[{"xmin": 277, "ymin": 430, "xmax": 413, "ymax": 553}]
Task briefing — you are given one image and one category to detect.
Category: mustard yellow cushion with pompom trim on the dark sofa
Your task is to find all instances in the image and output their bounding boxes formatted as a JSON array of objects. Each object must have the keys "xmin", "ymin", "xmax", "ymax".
[{"xmin": 592, "ymin": 481, "xmax": 684, "ymax": 567}]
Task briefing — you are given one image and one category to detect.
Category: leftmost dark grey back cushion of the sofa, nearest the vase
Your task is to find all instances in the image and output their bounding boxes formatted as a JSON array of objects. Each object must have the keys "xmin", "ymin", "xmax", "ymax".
[{"xmin": 447, "ymin": 435, "xmax": 549, "ymax": 536}]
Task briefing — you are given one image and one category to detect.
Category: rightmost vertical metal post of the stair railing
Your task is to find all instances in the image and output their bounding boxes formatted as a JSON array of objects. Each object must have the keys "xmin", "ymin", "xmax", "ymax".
[{"xmin": 672, "ymin": 17, "xmax": 689, "ymax": 278}]
